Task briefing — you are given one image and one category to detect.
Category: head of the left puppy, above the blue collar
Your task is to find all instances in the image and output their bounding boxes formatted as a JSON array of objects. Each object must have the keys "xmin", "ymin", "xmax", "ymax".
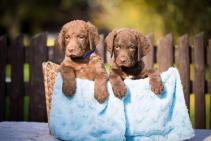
[{"xmin": 58, "ymin": 20, "xmax": 100, "ymax": 59}]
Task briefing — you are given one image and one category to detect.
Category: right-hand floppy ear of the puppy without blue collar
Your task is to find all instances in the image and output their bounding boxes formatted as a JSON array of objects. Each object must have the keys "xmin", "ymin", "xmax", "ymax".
[{"xmin": 136, "ymin": 32, "xmax": 152, "ymax": 61}]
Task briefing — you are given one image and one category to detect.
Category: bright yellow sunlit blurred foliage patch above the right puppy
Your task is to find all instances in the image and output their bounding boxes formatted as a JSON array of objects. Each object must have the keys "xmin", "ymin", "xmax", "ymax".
[{"xmin": 92, "ymin": 0, "xmax": 164, "ymax": 38}]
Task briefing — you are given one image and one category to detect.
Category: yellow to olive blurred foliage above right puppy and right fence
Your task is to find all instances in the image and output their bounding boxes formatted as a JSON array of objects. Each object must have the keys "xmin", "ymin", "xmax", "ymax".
[{"xmin": 92, "ymin": 0, "xmax": 211, "ymax": 37}]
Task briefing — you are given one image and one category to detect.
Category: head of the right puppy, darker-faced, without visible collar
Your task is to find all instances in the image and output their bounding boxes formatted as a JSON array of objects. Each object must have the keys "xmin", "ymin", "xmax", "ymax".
[{"xmin": 105, "ymin": 28, "xmax": 151, "ymax": 67}]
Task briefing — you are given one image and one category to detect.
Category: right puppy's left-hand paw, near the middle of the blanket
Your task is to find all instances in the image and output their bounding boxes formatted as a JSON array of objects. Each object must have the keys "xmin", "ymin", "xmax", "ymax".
[{"xmin": 112, "ymin": 82, "xmax": 127, "ymax": 99}]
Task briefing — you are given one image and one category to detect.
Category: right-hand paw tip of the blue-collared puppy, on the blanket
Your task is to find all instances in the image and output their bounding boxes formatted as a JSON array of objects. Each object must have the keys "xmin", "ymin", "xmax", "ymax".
[{"xmin": 94, "ymin": 87, "xmax": 108, "ymax": 103}]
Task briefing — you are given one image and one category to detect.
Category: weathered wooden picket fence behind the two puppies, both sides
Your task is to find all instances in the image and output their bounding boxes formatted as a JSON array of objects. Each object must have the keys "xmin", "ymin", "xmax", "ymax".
[{"xmin": 0, "ymin": 33, "xmax": 211, "ymax": 128}]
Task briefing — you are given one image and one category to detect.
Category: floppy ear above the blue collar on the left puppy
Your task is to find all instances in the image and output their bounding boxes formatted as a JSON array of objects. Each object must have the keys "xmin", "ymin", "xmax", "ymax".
[{"xmin": 87, "ymin": 22, "xmax": 100, "ymax": 50}]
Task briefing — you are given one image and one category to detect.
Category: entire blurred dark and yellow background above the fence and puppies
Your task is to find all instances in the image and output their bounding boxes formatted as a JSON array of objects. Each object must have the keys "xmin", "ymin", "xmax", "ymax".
[{"xmin": 0, "ymin": 0, "xmax": 211, "ymax": 38}]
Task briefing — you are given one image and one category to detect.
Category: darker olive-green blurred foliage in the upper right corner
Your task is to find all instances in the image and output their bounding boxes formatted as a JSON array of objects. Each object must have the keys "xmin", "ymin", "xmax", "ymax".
[{"xmin": 147, "ymin": 0, "xmax": 211, "ymax": 34}]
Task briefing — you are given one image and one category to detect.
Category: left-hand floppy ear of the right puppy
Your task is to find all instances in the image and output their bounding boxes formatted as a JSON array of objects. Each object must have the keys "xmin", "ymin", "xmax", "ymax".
[{"xmin": 105, "ymin": 30, "xmax": 117, "ymax": 58}]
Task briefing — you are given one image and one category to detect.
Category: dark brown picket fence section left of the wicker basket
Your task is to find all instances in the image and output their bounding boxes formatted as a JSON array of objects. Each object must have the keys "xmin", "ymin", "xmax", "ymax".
[{"xmin": 0, "ymin": 33, "xmax": 63, "ymax": 121}]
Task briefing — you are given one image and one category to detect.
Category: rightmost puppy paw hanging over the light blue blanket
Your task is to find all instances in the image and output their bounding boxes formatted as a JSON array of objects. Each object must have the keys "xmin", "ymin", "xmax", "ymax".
[{"xmin": 150, "ymin": 79, "xmax": 164, "ymax": 95}]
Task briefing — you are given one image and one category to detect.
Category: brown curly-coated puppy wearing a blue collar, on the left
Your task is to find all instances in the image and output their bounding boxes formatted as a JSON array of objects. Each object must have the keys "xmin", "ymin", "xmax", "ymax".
[{"xmin": 58, "ymin": 20, "xmax": 107, "ymax": 103}]
